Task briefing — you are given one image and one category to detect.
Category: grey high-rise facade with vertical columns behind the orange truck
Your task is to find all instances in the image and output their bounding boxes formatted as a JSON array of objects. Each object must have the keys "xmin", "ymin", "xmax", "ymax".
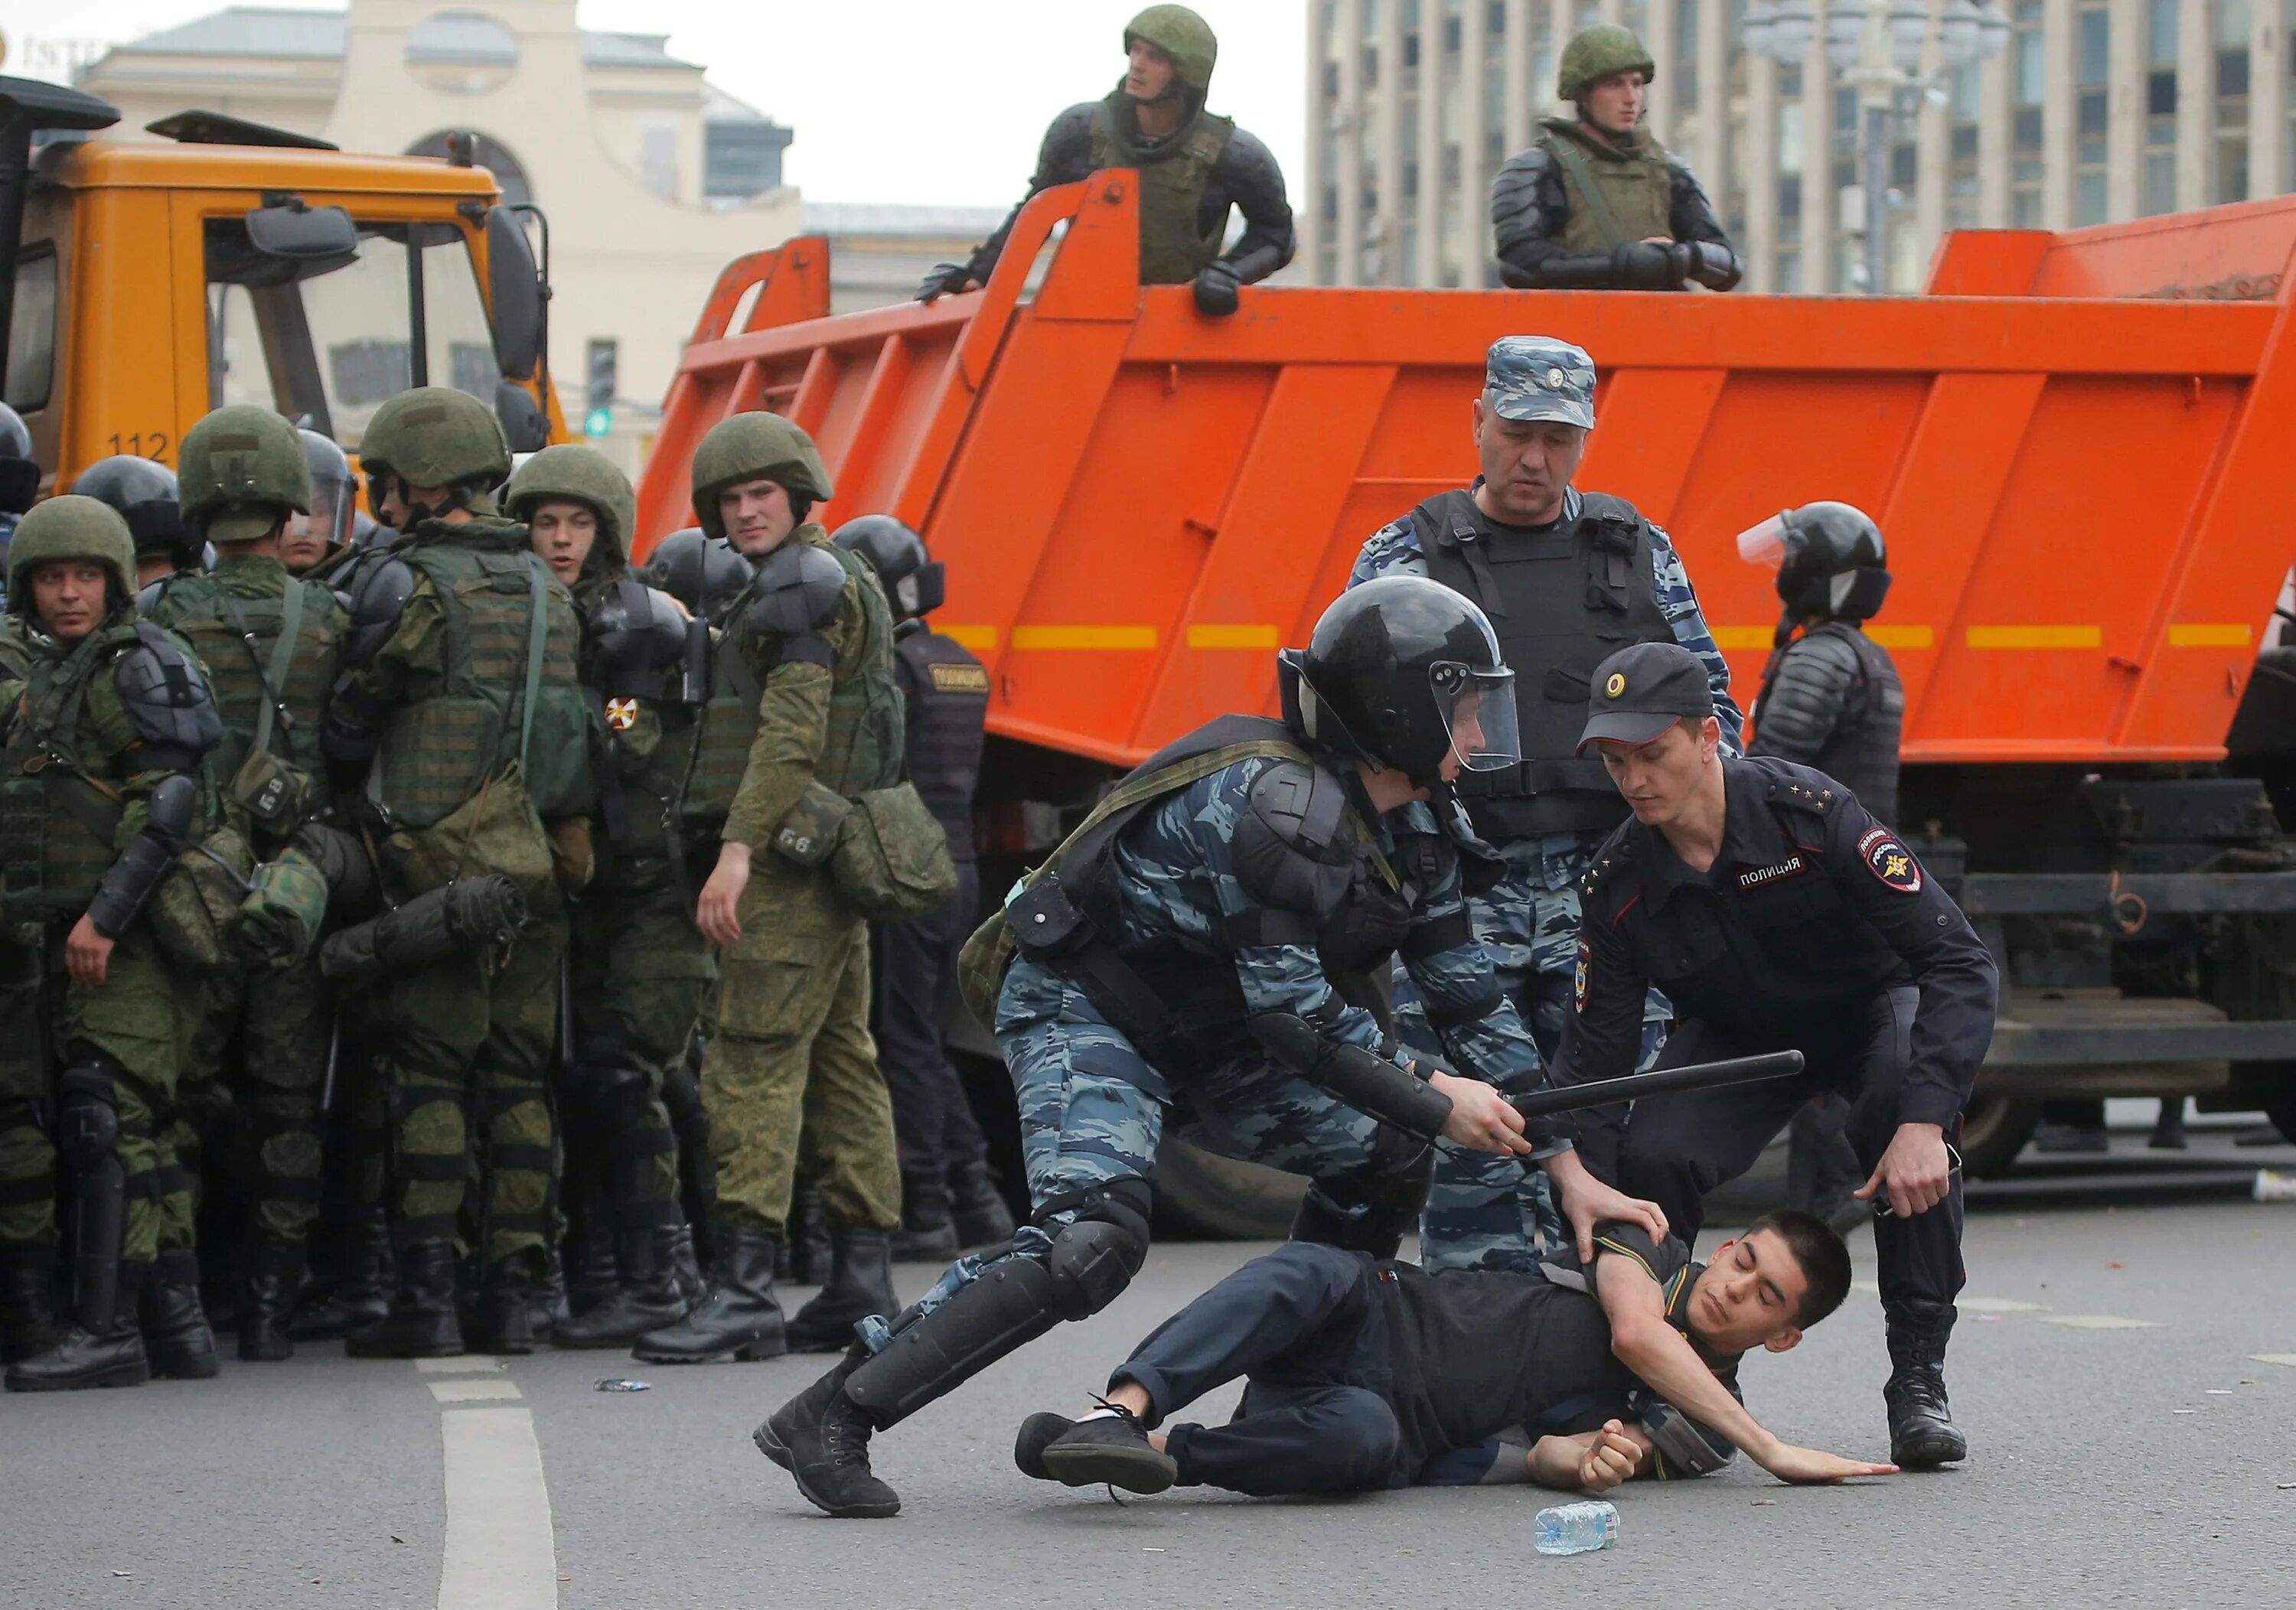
[{"xmin": 1300, "ymin": 0, "xmax": 2296, "ymax": 292}]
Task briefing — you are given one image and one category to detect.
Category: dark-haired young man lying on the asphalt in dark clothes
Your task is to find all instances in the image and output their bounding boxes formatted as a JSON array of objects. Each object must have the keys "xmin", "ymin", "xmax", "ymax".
[{"xmin": 1013, "ymin": 1213, "xmax": 1896, "ymax": 1495}]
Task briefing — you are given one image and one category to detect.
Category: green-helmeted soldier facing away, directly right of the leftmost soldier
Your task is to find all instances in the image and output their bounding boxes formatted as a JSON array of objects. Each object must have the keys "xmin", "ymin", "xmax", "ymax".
[{"xmin": 145, "ymin": 406, "xmax": 349, "ymax": 1360}]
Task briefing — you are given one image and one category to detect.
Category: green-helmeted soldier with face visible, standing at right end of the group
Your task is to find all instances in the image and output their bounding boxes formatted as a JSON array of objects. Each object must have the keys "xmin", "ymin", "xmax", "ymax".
[{"xmin": 636, "ymin": 413, "xmax": 902, "ymax": 1364}]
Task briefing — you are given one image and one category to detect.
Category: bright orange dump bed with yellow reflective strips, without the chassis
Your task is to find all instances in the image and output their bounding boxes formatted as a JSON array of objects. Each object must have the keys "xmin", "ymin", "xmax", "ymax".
[{"xmin": 638, "ymin": 172, "xmax": 2296, "ymax": 764}]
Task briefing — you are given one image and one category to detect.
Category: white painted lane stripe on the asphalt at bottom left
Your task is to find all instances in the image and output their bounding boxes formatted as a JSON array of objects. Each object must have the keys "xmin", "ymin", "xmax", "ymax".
[{"xmin": 439, "ymin": 1408, "xmax": 558, "ymax": 1610}]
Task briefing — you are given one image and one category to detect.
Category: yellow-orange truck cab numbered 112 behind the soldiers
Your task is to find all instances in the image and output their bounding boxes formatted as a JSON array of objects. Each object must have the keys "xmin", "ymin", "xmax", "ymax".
[{"xmin": 0, "ymin": 78, "xmax": 565, "ymax": 494}]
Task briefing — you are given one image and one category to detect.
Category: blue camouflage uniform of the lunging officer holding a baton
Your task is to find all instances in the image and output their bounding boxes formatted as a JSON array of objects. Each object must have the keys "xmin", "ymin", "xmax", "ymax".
[{"xmin": 863, "ymin": 758, "xmax": 1566, "ymax": 1351}]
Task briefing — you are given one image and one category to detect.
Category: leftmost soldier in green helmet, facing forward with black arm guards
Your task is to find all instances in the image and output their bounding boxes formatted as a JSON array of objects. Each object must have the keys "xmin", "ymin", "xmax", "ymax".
[{"xmin": 0, "ymin": 496, "xmax": 223, "ymax": 1392}]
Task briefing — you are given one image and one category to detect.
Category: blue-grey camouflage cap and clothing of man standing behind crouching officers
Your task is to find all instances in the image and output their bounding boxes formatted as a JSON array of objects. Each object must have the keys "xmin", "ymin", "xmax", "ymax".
[{"xmin": 1348, "ymin": 337, "xmax": 1743, "ymax": 1270}]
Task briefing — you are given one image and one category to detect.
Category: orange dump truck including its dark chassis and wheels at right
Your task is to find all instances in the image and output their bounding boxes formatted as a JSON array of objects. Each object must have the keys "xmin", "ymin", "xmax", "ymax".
[{"xmin": 638, "ymin": 172, "xmax": 2296, "ymax": 1169}]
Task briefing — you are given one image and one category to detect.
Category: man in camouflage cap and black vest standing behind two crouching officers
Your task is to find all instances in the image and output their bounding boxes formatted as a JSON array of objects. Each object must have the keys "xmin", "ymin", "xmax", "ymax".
[{"xmin": 1348, "ymin": 335, "xmax": 1740, "ymax": 1273}]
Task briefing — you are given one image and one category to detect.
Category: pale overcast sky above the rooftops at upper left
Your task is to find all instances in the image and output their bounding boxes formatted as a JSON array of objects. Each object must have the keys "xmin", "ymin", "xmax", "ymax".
[{"xmin": 0, "ymin": 0, "xmax": 1306, "ymax": 207}]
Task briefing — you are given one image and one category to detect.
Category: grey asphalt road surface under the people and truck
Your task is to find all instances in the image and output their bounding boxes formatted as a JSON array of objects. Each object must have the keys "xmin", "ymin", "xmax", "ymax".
[{"xmin": 0, "ymin": 1116, "xmax": 2296, "ymax": 1610}]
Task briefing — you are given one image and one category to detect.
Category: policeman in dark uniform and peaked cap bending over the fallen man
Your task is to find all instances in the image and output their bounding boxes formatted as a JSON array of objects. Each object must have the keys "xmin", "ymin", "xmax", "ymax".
[{"xmin": 1554, "ymin": 645, "xmax": 2000, "ymax": 1468}]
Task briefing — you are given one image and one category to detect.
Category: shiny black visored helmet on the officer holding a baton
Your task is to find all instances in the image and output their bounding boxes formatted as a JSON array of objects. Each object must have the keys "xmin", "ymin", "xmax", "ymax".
[{"xmin": 1277, "ymin": 576, "xmax": 1522, "ymax": 787}]
